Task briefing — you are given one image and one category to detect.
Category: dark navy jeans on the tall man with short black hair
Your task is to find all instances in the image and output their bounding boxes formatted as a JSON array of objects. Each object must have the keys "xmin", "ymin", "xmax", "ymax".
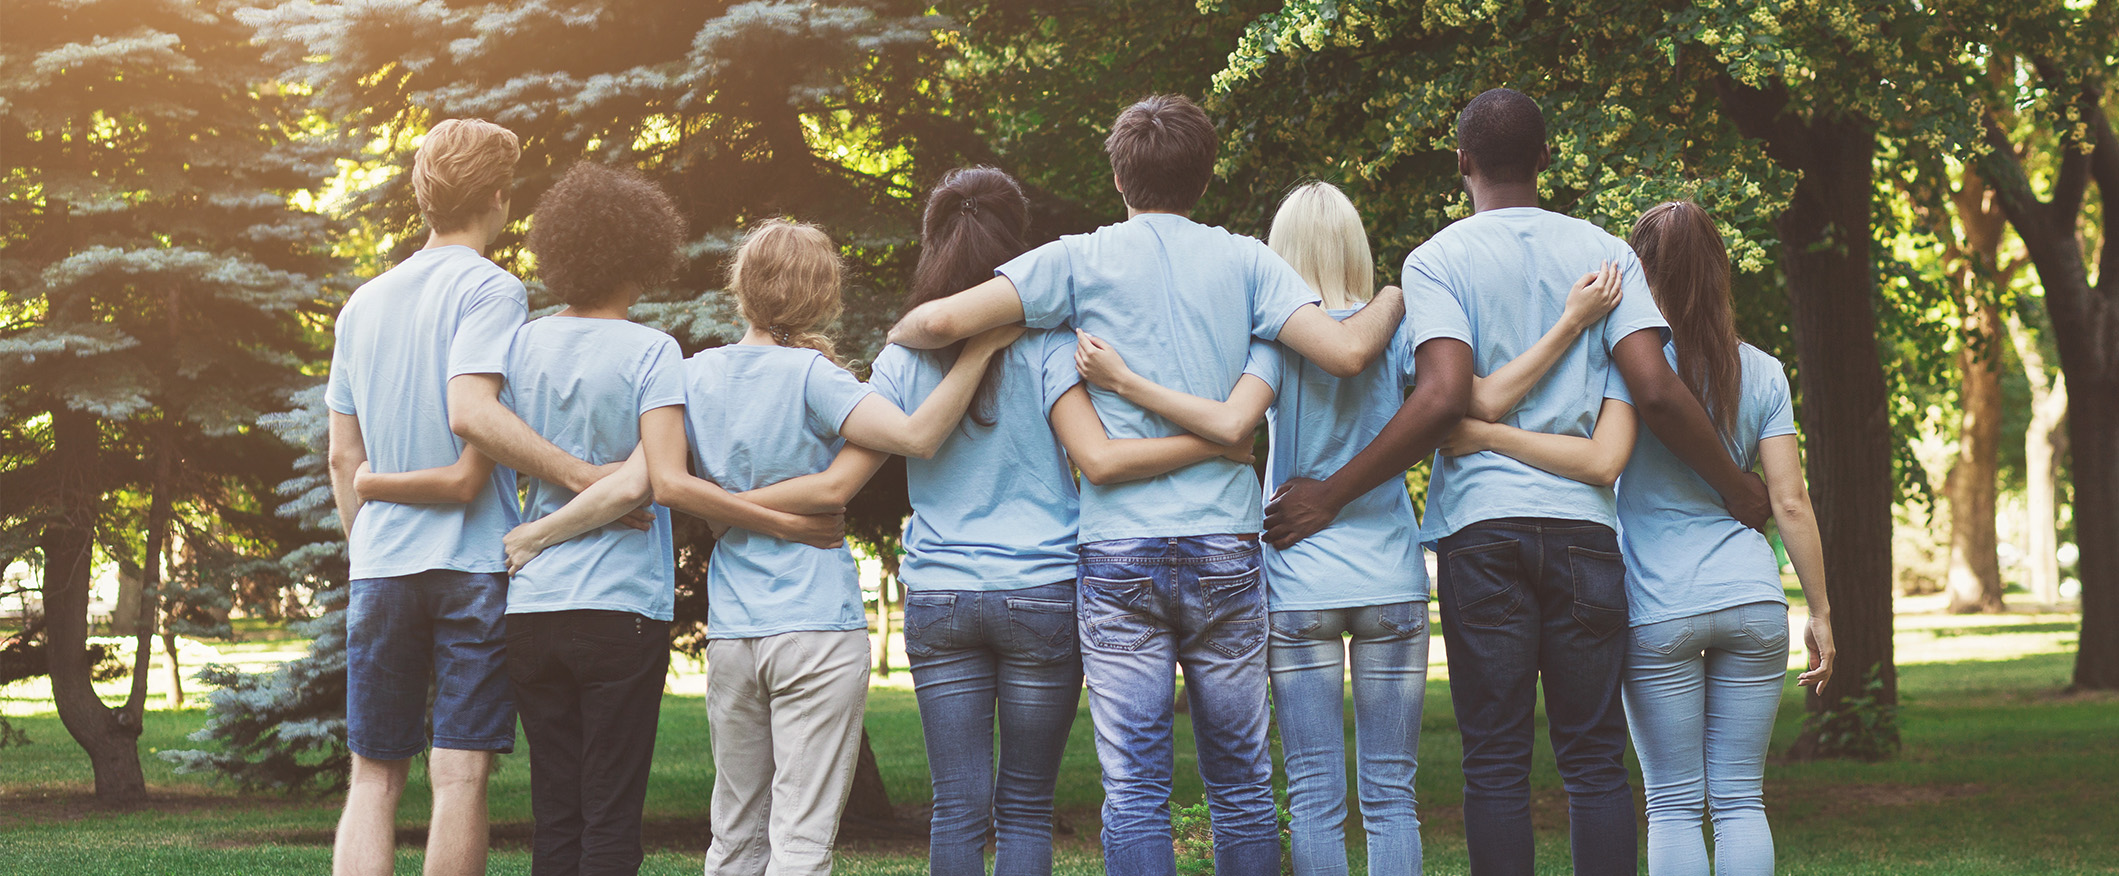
[{"xmin": 1439, "ymin": 518, "xmax": 1640, "ymax": 876}]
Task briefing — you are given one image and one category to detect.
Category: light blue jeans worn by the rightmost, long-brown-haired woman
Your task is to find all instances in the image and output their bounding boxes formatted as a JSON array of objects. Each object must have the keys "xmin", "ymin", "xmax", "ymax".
[{"xmin": 1625, "ymin": 602, "xmax": 1788, "ymax": 876}]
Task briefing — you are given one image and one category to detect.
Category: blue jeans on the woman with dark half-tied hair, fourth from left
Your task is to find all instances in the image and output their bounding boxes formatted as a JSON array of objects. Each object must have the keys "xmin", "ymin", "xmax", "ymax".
[{"xmin": 905, "ymin": 581, "xmax": 1081, "ymax": 876}]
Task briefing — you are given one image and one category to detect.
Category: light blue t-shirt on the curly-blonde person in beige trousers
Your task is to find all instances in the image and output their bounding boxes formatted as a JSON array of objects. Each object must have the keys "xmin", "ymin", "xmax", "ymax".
[{"xmin": 684, "ymin": 344, "xmax": 871, "ymax": 638}]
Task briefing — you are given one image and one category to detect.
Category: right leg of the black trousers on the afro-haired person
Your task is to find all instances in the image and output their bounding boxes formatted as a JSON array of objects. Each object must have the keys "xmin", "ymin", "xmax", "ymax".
[{"xmin": 572, "ymin": 611, "xmax": 670, "ymax": 876}]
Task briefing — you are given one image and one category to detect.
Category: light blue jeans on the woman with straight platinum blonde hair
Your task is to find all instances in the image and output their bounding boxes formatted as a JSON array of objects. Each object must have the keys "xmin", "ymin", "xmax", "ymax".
[{"xmin": 1265, "ymin": 602, "xmax": 1428, "ymax": 876}]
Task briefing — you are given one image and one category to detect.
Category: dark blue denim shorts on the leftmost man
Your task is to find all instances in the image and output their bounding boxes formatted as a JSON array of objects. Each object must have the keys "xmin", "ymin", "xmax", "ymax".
[{"xmin": 345, "ymin": 568, "xmax": 515, "ymax": 759}]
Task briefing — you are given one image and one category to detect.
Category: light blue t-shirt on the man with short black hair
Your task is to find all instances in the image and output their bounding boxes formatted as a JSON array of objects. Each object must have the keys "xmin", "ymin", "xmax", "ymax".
[{"xmin": 1405, "ymin": 208, "xmax": 1670, "ymax": 547}]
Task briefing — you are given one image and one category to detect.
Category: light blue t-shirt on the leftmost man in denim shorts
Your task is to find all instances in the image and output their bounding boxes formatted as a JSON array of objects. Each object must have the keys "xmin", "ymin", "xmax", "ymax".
[{"xmin": 324, "ymin": 246, "xmax": 528, "ymax": 579}]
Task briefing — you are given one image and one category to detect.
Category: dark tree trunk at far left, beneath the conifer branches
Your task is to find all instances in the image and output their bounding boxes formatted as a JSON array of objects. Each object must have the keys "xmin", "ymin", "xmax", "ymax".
[{"xmin": 38, "ymin": 409, "xmax": 146, "ymax": 804}]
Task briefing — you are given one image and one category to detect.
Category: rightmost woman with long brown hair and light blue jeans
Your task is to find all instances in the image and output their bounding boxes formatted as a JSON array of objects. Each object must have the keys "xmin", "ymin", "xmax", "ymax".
[{"xmin": 1452, "ymin": 202, "xmax": 1833, "ymax": 876}]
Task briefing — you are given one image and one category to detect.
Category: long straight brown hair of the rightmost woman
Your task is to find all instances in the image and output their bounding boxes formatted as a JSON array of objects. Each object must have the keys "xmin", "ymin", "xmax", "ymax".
[{"xmin": 1632, "ymin": 202, "xmax": 1744, "ymax": 439}]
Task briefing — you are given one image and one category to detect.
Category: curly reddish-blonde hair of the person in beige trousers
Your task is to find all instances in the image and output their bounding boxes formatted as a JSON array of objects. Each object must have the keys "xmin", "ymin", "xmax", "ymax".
[{"xmin": 729, "ymin": 218, "xmax": 843, "ymax": 365}]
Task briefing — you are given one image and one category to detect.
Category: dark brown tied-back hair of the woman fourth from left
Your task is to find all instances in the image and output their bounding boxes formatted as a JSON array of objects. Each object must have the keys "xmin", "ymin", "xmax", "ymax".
[{"xmin": 905, "ymin": 168, "xmax": 1030, "ymax": 426}]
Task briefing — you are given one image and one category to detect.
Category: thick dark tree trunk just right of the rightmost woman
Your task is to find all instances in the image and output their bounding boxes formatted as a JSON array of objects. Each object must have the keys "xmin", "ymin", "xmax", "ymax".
[{"xmin": 1721, "ymin": 78, "xmax": 1899, "ymax": 757}]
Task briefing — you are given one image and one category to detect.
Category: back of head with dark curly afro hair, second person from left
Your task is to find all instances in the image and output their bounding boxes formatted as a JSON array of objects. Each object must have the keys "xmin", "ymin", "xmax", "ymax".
[{"xmin": 530, "ymin": 161, "xmax": 684, "ymax": 308}]
